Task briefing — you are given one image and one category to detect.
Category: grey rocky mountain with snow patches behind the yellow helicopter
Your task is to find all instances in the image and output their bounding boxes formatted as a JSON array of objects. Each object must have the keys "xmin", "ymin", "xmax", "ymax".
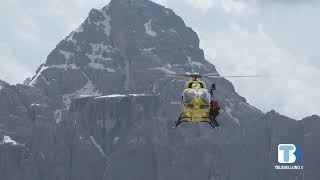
[{"xmin": 0, "ymin": 0, "xmax": 320, "ymax": 180}]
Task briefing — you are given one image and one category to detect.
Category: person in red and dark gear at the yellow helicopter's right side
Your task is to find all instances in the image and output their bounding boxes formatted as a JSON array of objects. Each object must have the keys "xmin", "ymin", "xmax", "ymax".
[{"xmin": 209, "ymin": 84, "xmax": 221, "ymax": 127}]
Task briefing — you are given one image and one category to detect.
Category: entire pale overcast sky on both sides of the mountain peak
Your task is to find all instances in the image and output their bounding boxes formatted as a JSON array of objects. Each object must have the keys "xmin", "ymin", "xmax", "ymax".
[{"xmin": 0, "ymin": 0, "xmax": 320, "ymax": 119}]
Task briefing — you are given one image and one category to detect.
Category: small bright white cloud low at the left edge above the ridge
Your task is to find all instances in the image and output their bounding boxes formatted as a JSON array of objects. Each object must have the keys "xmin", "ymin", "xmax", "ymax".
[{"xmin": 0, "ymin": 43, "xmax": 32, "ymax": 84}]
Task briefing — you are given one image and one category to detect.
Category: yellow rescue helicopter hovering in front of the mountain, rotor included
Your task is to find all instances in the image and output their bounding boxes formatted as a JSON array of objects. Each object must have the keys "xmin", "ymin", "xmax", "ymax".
[{"xmin": 169, "ymin": 73, "xmax": 261, "ymax": 128}]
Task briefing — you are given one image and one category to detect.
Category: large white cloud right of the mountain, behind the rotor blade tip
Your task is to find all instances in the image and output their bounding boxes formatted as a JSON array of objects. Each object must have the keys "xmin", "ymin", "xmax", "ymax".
[{"xmin": 202, "ymin": 23, "xmax": 320, "ymax": 119}]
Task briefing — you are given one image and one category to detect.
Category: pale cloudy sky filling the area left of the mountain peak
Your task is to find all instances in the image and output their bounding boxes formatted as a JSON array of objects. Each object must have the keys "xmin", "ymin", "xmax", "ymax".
[{"xmin": 0, "ymin": 0, "xmax": 108, "ymax": 83}]
